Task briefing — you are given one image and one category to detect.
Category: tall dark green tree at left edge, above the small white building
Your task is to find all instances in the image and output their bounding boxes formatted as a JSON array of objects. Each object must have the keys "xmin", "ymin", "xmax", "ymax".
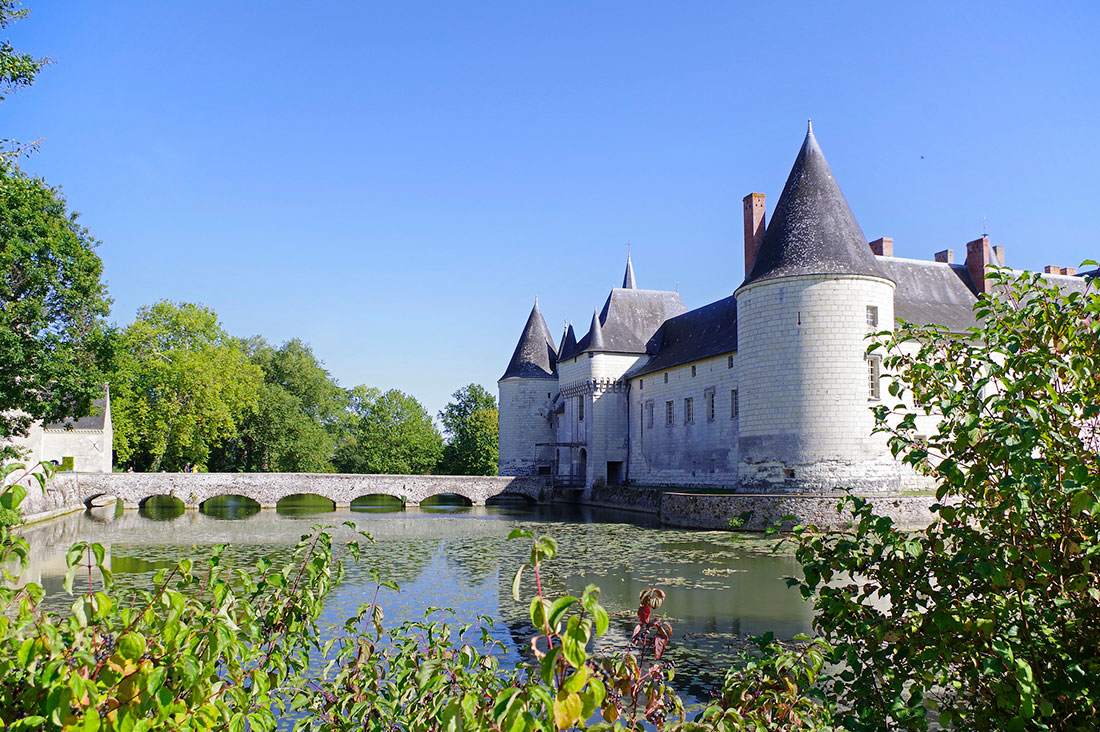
[{"xmin": 0, "ymin": 0, "xmax": 110, "ymax": 455}]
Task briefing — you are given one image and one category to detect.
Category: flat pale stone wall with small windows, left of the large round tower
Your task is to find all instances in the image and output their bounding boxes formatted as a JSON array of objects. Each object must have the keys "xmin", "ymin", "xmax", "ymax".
[{"xmin": 630, "ymin": 352, "xmax": 744, "ymax": 488}]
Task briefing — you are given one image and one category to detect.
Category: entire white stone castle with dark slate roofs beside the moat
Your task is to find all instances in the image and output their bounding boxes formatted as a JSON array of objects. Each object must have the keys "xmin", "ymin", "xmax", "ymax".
[{"xmin": 499, "ymin": 129, "xmax": 1084, "ymax": 492}]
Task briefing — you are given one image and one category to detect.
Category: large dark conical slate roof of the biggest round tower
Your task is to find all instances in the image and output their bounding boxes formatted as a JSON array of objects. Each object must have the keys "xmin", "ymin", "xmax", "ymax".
[{"xmin": 744, "ymin": 125, "xmax": 887, "ymax": 285}]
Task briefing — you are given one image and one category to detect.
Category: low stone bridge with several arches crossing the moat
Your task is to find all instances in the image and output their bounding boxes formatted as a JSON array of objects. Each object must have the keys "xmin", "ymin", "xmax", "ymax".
[{"xmin": 55, "ymin": 472, "xmax": 550, "ymax": 507}]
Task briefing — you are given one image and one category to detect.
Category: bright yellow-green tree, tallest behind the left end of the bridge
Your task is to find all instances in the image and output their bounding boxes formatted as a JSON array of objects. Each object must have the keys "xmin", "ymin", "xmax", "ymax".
[{"xmin": 111, "ymin": 301, "xmax": 263, "ymax": 471}]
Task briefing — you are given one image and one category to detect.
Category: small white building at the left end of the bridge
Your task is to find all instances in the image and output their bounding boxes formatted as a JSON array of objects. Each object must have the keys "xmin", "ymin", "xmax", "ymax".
[{"xmin": 12, "ymin": 391, "xmax": 114, "ymax": 472}]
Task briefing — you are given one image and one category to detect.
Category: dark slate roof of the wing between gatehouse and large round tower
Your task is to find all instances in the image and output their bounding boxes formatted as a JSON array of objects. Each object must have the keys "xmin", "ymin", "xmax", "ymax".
[{"xmin": 630, "ymin": 295, "xmax": 737, "ymax": 376}]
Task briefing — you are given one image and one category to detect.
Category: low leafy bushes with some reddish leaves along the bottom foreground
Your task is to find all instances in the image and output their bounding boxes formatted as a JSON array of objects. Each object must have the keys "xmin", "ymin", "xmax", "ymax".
[{"xmin": 0, "ymin": 466, "xmax": 828, "ymax": 732}]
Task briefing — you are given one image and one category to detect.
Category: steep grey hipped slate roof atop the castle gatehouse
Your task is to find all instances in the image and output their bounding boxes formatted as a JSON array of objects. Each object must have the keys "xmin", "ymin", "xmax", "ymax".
[{"xmin": 574, "ymin": 287, "xmax": 686, "ymax": 356}]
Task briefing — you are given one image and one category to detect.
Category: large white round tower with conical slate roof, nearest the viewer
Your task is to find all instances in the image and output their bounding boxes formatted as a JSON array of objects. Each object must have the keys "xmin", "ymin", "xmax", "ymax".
[{"xmin": 735, "ymin": 127, "xmax": 901, "ymax": 492}]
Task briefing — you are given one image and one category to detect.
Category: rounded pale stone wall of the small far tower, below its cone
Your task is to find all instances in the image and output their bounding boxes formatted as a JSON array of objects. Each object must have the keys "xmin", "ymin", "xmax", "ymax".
[{"xmin": 498, "ymin": 379, "xmax": 558, "ymax": 476}]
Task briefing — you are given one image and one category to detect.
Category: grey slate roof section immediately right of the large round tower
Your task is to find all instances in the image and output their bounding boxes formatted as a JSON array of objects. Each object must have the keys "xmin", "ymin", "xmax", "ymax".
[{"xmin": 876, "ymin": 256, "xmax": 978, "ymax": 332}]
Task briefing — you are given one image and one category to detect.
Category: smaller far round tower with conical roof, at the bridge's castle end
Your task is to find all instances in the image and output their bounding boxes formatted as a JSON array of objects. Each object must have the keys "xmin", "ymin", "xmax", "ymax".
[{"xmin": 497, "ymin": 297, "xmax": 558, "ymax": 476}]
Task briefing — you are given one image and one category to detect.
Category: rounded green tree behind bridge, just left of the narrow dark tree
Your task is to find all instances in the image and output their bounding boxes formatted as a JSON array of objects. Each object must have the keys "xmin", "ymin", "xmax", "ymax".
[{"xmin": 333, "ymin": 385, "xmax": 443, "ymax": 474}]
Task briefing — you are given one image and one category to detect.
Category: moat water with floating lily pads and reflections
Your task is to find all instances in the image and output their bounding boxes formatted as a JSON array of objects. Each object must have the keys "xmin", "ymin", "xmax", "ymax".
[{"xmin": 15, "ymin": 498, "xmax": 811, "ymax": 701}]
